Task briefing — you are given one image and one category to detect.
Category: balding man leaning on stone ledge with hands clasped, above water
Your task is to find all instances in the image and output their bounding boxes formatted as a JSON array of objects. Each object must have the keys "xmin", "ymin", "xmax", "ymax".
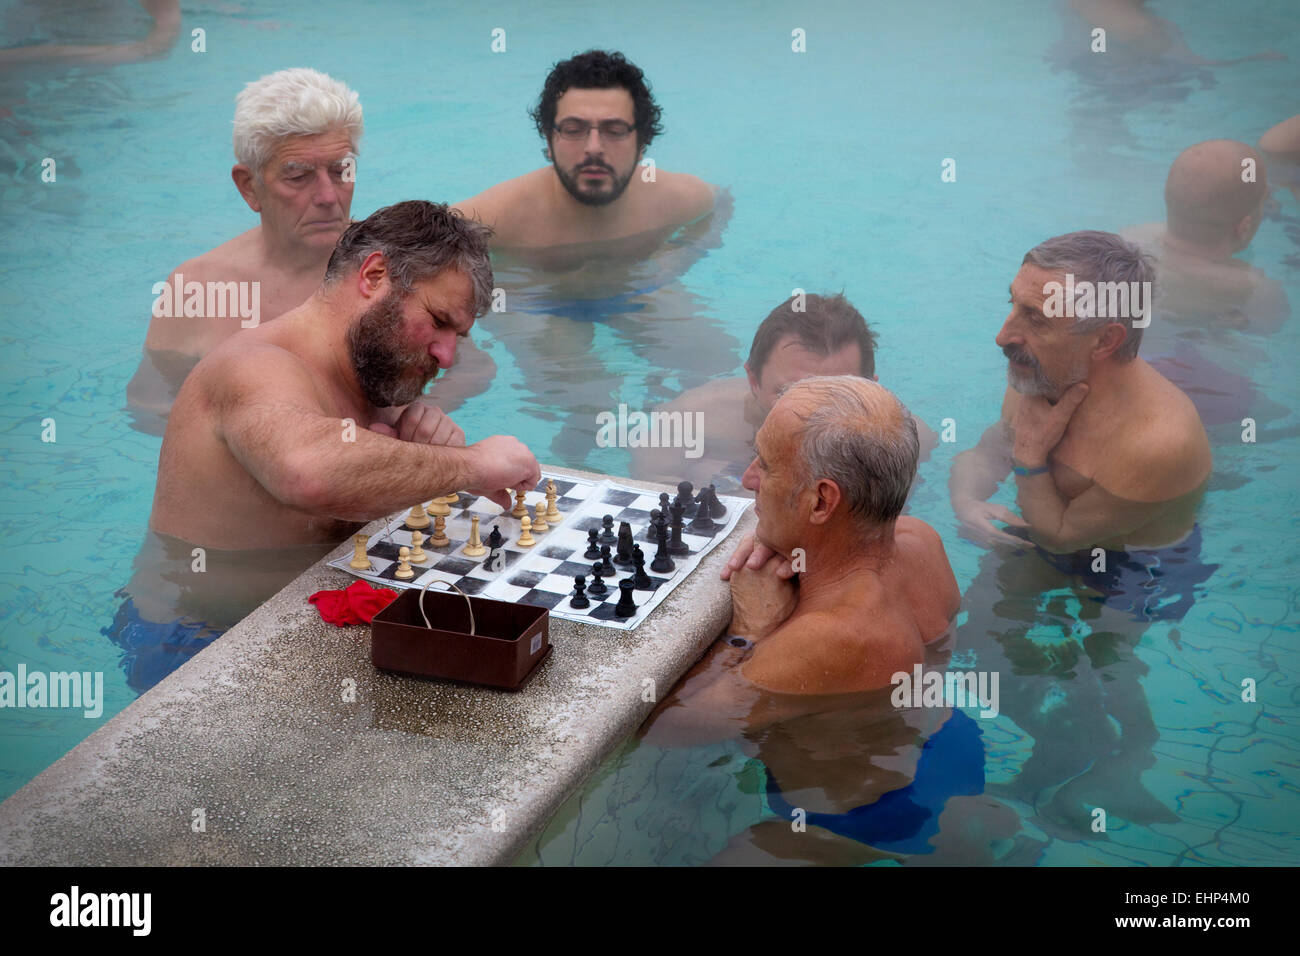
[{"xmin": 692, "ymin": 376, "xmax": 961, "ymax": 706}]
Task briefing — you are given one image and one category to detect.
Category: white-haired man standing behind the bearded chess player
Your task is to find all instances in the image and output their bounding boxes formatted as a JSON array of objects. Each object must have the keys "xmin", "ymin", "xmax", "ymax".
[{"xmin": 126, "ymin": 69, "xmax": 363, "ymax": 432}]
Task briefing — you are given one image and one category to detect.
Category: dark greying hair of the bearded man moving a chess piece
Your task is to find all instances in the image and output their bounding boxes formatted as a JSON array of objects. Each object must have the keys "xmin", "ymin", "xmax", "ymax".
[{"xmin": 325, "ymin": 199, "xmax": 493, "ymax": 317}]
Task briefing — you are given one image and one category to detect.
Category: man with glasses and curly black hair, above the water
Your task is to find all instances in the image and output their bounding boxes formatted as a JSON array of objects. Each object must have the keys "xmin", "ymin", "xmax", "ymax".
[{"xmin": 456, "ymin": 49, "xmax": 714, "ymax": 252}]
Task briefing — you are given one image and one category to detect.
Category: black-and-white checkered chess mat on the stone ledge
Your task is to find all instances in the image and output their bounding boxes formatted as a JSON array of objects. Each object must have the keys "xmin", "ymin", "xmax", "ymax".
[{"xmin": 329, "ymin": 472, "xmax": 751, "ymax": 631}]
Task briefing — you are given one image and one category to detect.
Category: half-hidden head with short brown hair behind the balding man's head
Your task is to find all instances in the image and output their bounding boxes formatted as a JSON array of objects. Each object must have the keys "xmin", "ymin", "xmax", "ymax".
[{"xmin": 745, "ymin": 294, "xmax": 876, "ymax": 415}]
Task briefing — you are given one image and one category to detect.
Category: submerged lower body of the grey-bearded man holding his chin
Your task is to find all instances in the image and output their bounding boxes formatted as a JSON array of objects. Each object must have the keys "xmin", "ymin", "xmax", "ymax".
[{"xmin": 957, "ymin": 527, "xmax": 1218, "ymax": 836}]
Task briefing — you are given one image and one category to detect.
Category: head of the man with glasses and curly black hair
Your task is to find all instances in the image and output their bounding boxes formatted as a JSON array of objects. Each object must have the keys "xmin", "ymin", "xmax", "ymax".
[{"xmin": 530, "ymin": 49, "xmax": 662, "ymax": 206}]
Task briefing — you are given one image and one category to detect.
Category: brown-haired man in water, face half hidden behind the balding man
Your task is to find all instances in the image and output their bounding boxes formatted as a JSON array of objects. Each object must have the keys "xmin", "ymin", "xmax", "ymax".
[{"xmin": 632, "ymin": 293, "xmax": 937, "ymax": 493}]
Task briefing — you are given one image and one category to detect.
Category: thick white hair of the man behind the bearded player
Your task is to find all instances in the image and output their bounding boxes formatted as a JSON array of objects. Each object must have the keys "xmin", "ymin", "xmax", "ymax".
[{"xmin": 234, "ymin": 68, "xmax": 363, "ymax": 182}]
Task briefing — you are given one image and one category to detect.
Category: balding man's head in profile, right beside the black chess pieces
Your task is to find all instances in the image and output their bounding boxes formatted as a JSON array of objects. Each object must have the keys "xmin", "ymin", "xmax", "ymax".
[{"xmin": 745, "ymin": 375, "xmax": 920, "ymax": 555}]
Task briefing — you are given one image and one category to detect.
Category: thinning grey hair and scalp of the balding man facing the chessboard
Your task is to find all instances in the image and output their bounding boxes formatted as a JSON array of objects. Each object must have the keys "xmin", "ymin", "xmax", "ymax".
[{"xmin": 781, "ymin": 375, "xmax": 920, "ymax": 529}]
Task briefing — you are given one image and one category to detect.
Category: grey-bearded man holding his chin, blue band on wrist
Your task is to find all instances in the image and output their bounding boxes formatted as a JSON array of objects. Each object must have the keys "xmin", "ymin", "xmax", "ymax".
[{"xmin": 949, "ymin": 232, "xmax": 1210, "ymax": 554}]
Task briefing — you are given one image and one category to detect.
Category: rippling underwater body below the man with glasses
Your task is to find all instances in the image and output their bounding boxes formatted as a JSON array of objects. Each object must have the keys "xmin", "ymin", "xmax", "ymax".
[{"xmin": 478, "ymin": 191, "xmax": 740, "ymax": 467}]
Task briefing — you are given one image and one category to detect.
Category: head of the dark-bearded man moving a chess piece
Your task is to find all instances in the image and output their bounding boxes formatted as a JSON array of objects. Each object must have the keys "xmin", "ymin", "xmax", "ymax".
[{"xmin": 325, "ymin": 200, "xmax": 493, "ymax": 408}]
